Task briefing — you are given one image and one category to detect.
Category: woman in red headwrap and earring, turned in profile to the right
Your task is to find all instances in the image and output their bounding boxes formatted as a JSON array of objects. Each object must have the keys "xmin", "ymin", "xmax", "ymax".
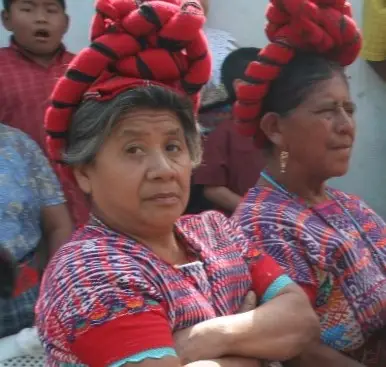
[{"xmin": 235, "ymin": 1, "xmax": 386, "ymax": 366}]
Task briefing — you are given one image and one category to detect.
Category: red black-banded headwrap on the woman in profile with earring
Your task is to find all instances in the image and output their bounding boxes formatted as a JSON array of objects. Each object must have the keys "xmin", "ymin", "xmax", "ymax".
[{"xmin": 234, "ymin": 0, "xmax": 362, "ymax": 146}]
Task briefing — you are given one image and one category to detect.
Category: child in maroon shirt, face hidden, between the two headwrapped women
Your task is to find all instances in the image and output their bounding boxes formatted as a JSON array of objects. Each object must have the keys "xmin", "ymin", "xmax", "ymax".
[{"xmin": 194, "ymin": 47, "xmax": 264, "ymax": 215}]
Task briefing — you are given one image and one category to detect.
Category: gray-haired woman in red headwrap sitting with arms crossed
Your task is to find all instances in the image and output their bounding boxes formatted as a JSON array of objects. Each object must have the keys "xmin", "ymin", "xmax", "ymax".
[{"xmin": 37, "ymin": 0, "xmax": 318, "ymax": 367}]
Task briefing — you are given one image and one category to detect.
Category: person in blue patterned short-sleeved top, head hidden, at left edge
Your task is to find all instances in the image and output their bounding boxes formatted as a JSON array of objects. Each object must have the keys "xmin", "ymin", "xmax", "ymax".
[{"xmin": 0, "ymin": 124, "xmax": 72, "ymax": 338}]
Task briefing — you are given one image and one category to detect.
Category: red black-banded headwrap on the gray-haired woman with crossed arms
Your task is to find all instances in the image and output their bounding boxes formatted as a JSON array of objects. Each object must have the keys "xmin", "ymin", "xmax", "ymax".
[{"xmin": 45, "ymin": 0, "xmax": 211, "ymax": 162}]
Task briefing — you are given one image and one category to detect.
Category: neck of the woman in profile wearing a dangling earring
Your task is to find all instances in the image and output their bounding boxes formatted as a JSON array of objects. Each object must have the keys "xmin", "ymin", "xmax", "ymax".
[{"xmin": 259, "ymin": 162, "xmax": 328, "ymax": 205}]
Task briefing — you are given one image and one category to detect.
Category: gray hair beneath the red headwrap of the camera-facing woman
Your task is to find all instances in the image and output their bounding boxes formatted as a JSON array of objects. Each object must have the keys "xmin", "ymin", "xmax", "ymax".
[{"xmin": 63, "ymin": 85, "xmax": 202, "ymax": 166}]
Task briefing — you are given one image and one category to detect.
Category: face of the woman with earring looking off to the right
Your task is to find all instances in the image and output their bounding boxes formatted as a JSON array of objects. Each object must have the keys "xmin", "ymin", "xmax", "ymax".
[{"xmin": 281, "ymin": 74, "xmax": 355, "ymax": 180}]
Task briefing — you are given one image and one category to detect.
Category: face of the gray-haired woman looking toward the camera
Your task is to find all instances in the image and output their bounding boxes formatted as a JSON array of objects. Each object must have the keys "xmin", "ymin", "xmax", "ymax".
[{"xmin": 75, "ymin": 109, "xmax": 192, "ymax": 235}]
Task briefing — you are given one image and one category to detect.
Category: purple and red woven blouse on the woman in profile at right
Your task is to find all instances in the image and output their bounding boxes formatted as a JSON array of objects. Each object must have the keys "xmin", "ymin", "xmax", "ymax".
[{"xmin": 235, "ymin": 186, "xmax": 386, "ymax": 358}]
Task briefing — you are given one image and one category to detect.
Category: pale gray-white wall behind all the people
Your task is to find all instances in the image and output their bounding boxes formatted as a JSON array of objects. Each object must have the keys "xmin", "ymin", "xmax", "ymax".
[{"xmin": 0, "ymin": 0, "xmax": 386, "ymax": 218}]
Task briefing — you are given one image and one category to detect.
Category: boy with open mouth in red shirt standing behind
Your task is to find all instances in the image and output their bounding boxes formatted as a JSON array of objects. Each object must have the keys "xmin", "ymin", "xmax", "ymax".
[{"xmin": 0, "ymin": 0, "xmax": 88, "ymax": 223}]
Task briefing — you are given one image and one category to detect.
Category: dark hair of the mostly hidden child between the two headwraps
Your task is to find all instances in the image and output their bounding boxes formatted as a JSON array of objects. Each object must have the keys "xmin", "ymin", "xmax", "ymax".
[{"xmin": 221, "ymin": 47, "xmax": 260, "ymax": 103}]
